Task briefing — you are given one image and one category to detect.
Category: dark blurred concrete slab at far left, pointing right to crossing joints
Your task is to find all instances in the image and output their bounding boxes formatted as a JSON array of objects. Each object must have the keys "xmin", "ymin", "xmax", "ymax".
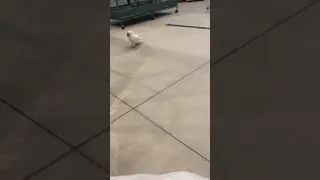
[{"xmin": 0, "ymin": 102, "xmax": 70, "ymax": 180}]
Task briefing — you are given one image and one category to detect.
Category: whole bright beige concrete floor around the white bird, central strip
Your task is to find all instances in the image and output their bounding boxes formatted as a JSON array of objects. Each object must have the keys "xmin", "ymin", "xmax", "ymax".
[{"xmin": 110, "ymin": 1, "xmax": 210, "ymax": 177}]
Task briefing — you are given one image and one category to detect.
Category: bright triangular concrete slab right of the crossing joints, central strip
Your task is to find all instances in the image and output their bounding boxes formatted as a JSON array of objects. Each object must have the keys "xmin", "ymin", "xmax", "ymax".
[{"xmin": 137, "ymin": 64, "xmax": 210, "ymax": 160}]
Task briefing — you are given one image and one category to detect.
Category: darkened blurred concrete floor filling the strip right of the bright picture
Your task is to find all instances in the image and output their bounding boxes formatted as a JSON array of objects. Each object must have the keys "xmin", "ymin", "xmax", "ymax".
[{"xmin": 210, "ymin": 0, "xmax": 320, "ymax": 180}]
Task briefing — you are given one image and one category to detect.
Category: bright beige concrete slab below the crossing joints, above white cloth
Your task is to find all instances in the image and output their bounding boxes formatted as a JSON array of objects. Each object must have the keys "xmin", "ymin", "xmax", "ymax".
[{"xmin": 110, "ymin": 111, "xmax": 210, "ymax": 177}]
